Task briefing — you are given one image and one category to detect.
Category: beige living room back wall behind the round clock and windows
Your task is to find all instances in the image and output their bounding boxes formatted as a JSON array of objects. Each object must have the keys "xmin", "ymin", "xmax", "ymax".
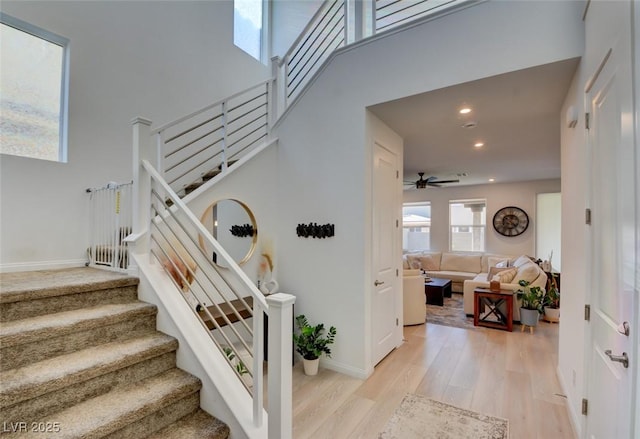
[{"xmin": 404, "ymin": 180, "xmax": 560, "ymax": 258}]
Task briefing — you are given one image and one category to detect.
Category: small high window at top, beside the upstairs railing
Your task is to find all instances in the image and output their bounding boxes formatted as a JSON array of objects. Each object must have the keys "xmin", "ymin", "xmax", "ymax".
[{"xmin": 233, "ymin": 0, "xmax": 264, "ymax": 61}]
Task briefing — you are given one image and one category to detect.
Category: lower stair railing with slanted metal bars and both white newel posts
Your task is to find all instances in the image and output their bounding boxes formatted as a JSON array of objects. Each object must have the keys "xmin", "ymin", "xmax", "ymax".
[{"xmin": 128, "ymin": 118, "xmax": 295, "ymax": 439}]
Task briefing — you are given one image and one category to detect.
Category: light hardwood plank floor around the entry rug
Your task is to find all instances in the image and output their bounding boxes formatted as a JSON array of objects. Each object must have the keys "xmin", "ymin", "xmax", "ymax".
[{"xmin": 293, "ymin": 321, "xmax": 575, "ymax": 439}]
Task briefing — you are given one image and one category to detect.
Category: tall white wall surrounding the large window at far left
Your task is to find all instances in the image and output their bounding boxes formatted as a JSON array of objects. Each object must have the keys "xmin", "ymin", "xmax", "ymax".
[{"xmin": 0, "ymin": 1, "xmax": 269, "ymax": 271}]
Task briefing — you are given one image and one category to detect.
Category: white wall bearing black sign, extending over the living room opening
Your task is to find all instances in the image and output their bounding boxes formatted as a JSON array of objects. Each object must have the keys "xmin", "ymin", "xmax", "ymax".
[{"xmin": 277, "ymin": 2, "xmax": 583, "ymax": 375}]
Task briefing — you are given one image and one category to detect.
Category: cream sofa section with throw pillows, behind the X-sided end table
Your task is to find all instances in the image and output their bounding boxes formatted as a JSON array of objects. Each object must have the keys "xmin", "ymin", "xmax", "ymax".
[{"xmin": 463, "ymin": 256, "xmax": 547, "ymax": 321}]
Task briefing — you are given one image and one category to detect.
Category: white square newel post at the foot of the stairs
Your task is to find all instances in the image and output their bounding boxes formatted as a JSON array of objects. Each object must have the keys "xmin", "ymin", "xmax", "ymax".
[{"xmin": 266, "ymin": 293, "xmax": 296, "ymax": 439}]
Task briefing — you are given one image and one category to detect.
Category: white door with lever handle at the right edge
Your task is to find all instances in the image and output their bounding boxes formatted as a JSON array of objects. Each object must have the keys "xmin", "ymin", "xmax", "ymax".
[{"xmin": 586, "ymin": 2, "xmax": 638, "ymax": 439}]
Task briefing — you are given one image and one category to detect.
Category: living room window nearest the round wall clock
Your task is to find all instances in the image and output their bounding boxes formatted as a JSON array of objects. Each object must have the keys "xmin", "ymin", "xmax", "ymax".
[{"xmin": 449, "ymin": 200, "xmax": 487, "ymax": 252}]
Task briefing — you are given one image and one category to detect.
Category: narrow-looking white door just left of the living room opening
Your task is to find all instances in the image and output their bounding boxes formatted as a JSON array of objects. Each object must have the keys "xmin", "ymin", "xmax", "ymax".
[{"xmin": 371, "ymin": 143, "xmax": 400, "ymax": 365}]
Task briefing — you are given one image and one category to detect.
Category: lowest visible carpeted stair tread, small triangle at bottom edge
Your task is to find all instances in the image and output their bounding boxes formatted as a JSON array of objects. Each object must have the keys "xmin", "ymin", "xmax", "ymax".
[{"xmin": 148, "ymin": 409, "xmax": 229, "ymax": 439}]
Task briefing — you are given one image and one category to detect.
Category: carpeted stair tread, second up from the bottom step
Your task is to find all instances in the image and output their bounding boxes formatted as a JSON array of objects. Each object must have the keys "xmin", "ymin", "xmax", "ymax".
[{"xmin": 11, "ymin": 369, "xmax": 201, "ymax": 439}]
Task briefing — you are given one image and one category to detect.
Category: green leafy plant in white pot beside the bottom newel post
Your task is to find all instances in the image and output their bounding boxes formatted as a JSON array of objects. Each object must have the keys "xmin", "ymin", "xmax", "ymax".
[{"xmin": 293, "ymin": 314, "xmax": 336, "ymax": 375}]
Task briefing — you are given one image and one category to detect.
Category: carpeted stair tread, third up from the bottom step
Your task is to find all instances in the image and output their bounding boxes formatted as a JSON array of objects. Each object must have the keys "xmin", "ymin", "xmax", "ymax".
[{"xmin": 0, "ymin": 333, "xmax": 178, "ymax": 407}]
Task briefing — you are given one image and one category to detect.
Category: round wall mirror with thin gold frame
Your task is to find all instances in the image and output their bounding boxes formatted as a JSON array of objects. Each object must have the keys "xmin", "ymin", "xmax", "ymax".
[{"xmin": 199, "ymin": 199, "xmax": 258, "ymax": 267}]
